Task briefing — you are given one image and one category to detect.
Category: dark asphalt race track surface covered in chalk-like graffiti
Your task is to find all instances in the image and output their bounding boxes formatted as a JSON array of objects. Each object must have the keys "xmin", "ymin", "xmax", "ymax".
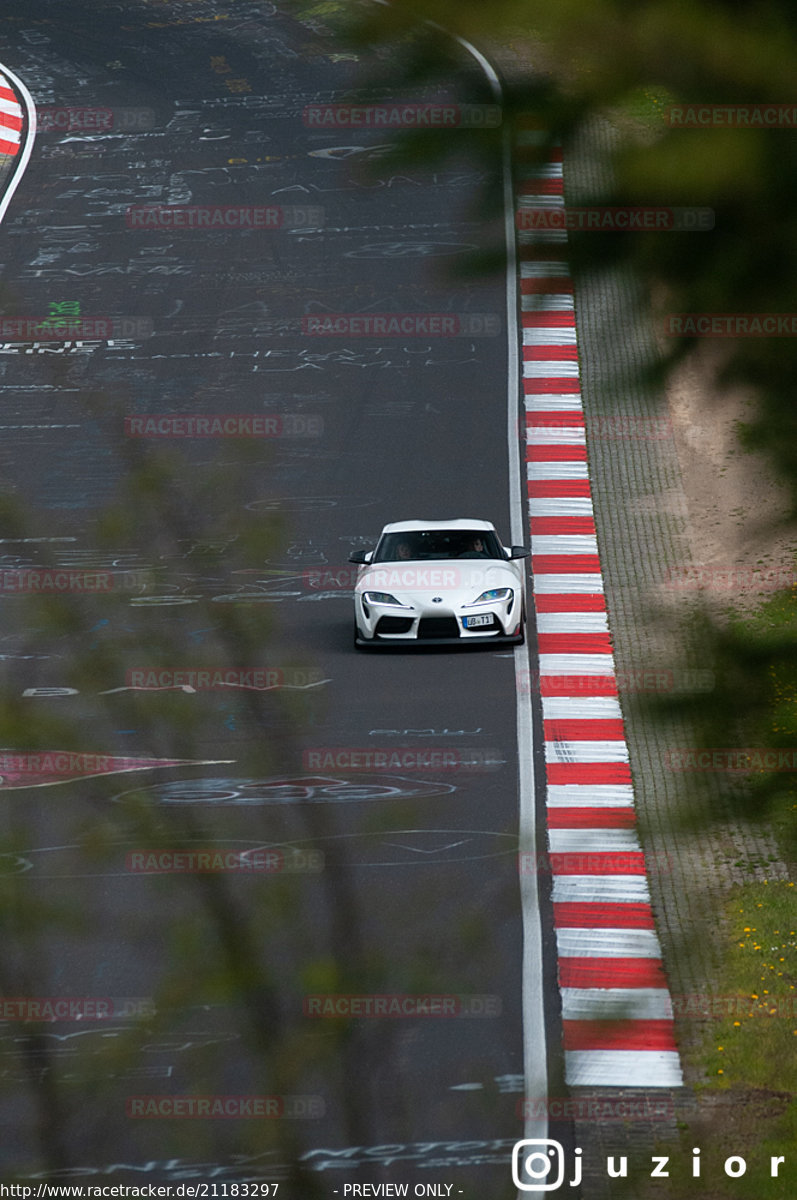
[{"xmin": 0, "ymin": 0, "xmax": 561, "ymax": 1200}]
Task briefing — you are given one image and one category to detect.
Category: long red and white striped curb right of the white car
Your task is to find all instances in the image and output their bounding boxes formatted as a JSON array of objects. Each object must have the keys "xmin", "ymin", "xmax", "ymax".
[{"xmin": 515, "ymin": 122, "xmax": 683, "ymax": 1088}]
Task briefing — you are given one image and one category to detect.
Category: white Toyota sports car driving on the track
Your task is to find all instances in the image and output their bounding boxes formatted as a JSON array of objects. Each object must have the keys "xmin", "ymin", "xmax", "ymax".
[{"xmin": 349, "ymin": 521, "xmax": 528, "ymax": 648}]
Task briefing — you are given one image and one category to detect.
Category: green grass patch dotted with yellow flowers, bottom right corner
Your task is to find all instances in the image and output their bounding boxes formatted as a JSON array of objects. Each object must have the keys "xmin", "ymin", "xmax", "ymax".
[{"xmin": 670, "ymin": 880, "xmax": 797, "ymax": 1200}]
